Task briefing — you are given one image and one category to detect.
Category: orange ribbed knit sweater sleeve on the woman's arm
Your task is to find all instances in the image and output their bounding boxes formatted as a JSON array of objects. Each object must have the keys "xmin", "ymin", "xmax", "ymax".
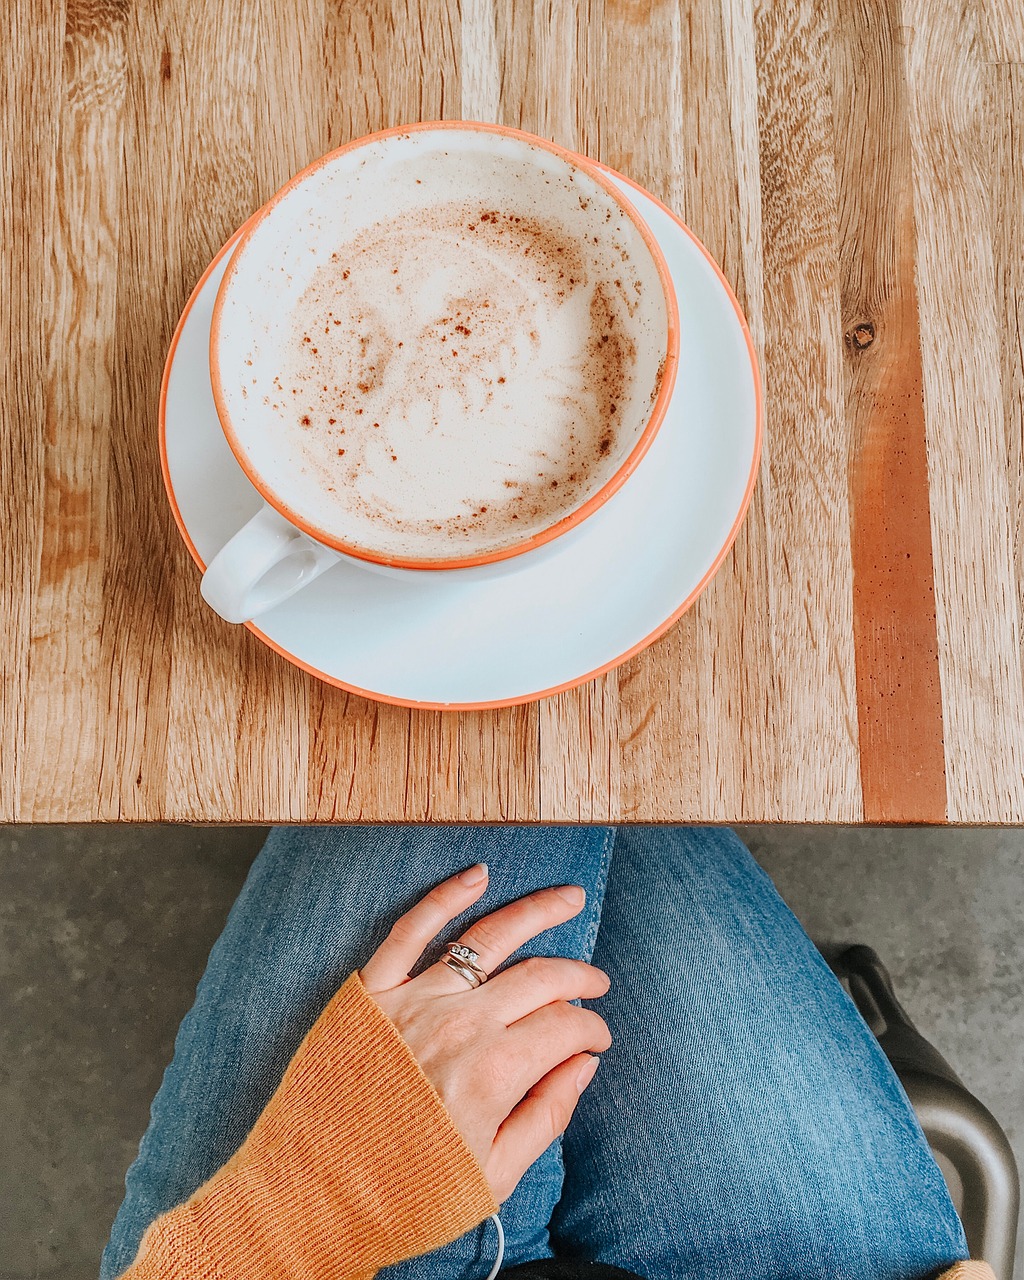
[{"xmin": 117, "ymin": 973, "xmax": 498, "ymax": 1280}]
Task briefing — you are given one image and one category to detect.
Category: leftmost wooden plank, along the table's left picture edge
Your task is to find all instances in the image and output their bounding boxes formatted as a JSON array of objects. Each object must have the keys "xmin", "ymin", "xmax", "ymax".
[{"xmin": 0, "ymin": 0, "xmax": 65, "ymax": 822}]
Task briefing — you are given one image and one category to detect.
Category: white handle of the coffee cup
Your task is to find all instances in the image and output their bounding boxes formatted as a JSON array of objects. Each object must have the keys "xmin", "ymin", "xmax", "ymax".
[{"xmin": 200, "ymin": 504, "xmax": 342, "ymax": 622}]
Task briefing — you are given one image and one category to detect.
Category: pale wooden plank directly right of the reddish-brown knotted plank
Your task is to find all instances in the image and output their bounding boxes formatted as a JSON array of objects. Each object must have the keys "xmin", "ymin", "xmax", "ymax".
[{"xmin": 902, "ymin": 0, "xmax": 1024, "ymax": 822}]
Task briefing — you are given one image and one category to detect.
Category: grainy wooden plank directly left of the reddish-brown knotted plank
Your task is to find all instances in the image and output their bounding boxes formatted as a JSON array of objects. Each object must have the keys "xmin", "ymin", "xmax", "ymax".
[{"xmin": 754, "ymin": 0, "xmax": 863, "ymax": 822}]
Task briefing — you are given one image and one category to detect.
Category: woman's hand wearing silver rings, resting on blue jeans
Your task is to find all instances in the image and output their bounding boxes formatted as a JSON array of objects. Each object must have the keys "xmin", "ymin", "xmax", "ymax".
[{"xmin": 360, "ymin": 865, "xmax": 612, "ymax": 1203}]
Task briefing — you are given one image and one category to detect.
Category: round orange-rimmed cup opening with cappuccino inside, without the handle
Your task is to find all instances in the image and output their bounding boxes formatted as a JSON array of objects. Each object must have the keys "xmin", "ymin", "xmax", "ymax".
[{"xmin": 217, "ymin": 132, "xmax": 678, "ymax": 570}]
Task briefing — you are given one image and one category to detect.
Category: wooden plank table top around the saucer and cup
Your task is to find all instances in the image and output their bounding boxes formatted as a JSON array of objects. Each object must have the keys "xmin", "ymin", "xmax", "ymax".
[{"xmin": 0, "ymin": 0, "xmax": 1024, "ymax": 823}]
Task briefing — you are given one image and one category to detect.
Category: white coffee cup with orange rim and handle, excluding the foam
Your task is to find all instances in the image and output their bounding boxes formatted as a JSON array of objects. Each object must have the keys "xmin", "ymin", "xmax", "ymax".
[{"xmin": 201, "ymin": 122, "xmax": 678, "ymax": 622}]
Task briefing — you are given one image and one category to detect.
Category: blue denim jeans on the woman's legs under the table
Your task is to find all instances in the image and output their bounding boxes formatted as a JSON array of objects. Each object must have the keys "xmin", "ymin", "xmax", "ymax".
[{"xmin": 101, "ymin": 827, "xmax": 966, "ymax": 1280}]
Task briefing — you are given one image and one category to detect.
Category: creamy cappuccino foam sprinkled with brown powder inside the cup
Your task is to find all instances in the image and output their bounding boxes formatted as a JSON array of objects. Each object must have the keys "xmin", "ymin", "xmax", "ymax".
[{"xmin": 222, "ymin": 137, "xmax": 662, "ymax": 562}]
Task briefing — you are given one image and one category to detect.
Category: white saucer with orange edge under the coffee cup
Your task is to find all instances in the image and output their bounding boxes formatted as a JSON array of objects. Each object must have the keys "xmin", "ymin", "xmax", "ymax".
[{"xmin": 160, "ymin": 170, "xmax": 762, "ymax": 709}]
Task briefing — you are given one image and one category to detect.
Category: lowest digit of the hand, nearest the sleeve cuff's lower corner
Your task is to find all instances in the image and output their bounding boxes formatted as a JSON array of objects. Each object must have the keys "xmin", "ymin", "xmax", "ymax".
[{"xmin": 488, "ymin": 1053, "xmax": 600, "ymax": 1202}]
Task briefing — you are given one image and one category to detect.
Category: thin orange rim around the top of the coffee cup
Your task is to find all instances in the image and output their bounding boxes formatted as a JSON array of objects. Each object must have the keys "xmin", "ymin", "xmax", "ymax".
[{"xmin": 210, "ymin": 120, "xmax": 680, "ymax": 570}]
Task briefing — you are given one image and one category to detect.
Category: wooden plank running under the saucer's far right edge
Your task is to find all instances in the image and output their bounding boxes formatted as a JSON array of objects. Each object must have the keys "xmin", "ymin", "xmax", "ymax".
[{"xmin": 668, "ymin": 0, "xmax": 776, "ymax": 820}]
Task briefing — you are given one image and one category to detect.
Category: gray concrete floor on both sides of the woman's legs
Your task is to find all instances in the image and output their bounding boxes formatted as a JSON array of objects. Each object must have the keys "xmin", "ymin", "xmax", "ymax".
[{"xmin": 0, "ymin": 827, "xmax": 1024, "ymax": 1280}]
